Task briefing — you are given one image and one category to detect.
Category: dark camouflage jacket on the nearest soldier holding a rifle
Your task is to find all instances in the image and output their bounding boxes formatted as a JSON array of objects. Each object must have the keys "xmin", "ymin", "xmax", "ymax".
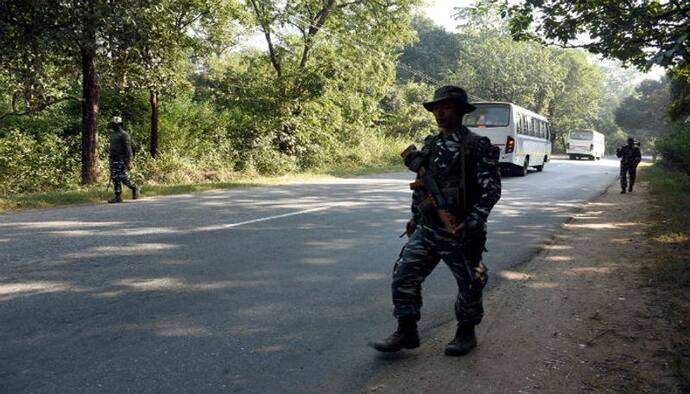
[{"xmin": 412, "ymin": 127, "xmax": 501, "ymax": 228}]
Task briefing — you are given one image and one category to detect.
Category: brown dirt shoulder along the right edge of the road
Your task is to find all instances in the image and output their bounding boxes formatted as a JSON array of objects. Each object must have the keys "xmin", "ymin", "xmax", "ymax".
[{"xmin": 364, "ymin": 184, "xmax": 690, "ymax": 393}]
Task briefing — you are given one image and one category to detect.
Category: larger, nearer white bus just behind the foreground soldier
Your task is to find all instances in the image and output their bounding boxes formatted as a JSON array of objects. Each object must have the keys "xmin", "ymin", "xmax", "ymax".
[{"xmin": 463, "ymin": 102, "xmax": 551, "ymax": 176}]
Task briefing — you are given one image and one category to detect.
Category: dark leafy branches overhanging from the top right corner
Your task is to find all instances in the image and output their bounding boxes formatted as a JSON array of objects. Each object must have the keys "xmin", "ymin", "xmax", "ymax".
[{"xmin": 502, "ymin": 0, "xmax": 690, "ymax": 70}]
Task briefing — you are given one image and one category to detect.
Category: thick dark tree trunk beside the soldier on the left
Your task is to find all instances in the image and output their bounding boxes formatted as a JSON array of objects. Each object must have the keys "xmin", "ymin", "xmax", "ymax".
[{"xmin": 81, "ymin": 0, "xmax": 99, "ymax": 184}]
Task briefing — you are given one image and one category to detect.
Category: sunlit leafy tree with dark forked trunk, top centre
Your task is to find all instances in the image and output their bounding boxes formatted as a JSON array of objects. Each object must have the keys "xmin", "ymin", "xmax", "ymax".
[{"xmin": 221, "ymin": 0, "xmax": 418, "ymax": 159}]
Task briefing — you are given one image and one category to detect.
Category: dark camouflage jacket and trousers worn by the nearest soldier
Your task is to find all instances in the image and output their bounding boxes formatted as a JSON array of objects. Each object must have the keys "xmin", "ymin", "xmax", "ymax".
[{"xmin": 392, "ymin": 127, "xmax": 501, "ymax": 324}]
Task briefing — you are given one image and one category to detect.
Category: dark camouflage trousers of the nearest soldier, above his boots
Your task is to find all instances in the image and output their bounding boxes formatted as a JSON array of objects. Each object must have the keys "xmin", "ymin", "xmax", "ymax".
[{"xmin": 392, "ymin": 226, "xmax": 488, "ymax": 324}]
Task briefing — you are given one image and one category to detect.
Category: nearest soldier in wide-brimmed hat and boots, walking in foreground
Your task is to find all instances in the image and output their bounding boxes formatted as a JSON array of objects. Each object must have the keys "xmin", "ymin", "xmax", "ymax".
[{"xmin": 370, "ymin": 86, "xmax": 501, "ymax": 356}]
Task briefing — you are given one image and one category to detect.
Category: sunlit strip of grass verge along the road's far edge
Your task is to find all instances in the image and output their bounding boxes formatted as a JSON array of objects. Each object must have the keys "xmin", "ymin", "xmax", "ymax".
[{"xmin": 0, "ymin": 164, "xmax": 404, "ymax": 213}]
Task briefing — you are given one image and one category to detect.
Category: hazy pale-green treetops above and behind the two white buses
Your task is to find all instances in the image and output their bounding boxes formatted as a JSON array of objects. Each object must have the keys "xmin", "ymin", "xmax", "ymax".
[{"xmin": 450, "ymin": 30, "xmax": 603, "ymax": 147}]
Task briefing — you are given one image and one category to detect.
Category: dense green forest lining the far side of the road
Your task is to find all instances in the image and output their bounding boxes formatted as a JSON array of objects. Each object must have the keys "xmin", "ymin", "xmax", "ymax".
[{"xmin": 0, "ymin": 0, "xmax": 682, "ymax": 194}]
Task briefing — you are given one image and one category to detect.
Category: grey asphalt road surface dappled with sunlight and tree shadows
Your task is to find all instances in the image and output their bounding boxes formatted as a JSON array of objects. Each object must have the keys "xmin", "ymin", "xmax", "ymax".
[{"xmin": 0, "ymin": 160, "xmax": 618, "ymax": 393}]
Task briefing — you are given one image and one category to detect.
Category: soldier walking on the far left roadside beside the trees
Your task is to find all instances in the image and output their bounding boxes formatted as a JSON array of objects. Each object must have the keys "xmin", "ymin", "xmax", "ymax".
[{"xmin": 108, "ymin": 116, "xmax": 140, "ymax": 203}]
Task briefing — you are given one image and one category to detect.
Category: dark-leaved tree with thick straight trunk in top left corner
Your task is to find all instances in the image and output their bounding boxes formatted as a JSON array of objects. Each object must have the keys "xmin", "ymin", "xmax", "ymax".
[{"xmin": 0, "ymin": 0, "xmax": 108, "ymax": 184}]
